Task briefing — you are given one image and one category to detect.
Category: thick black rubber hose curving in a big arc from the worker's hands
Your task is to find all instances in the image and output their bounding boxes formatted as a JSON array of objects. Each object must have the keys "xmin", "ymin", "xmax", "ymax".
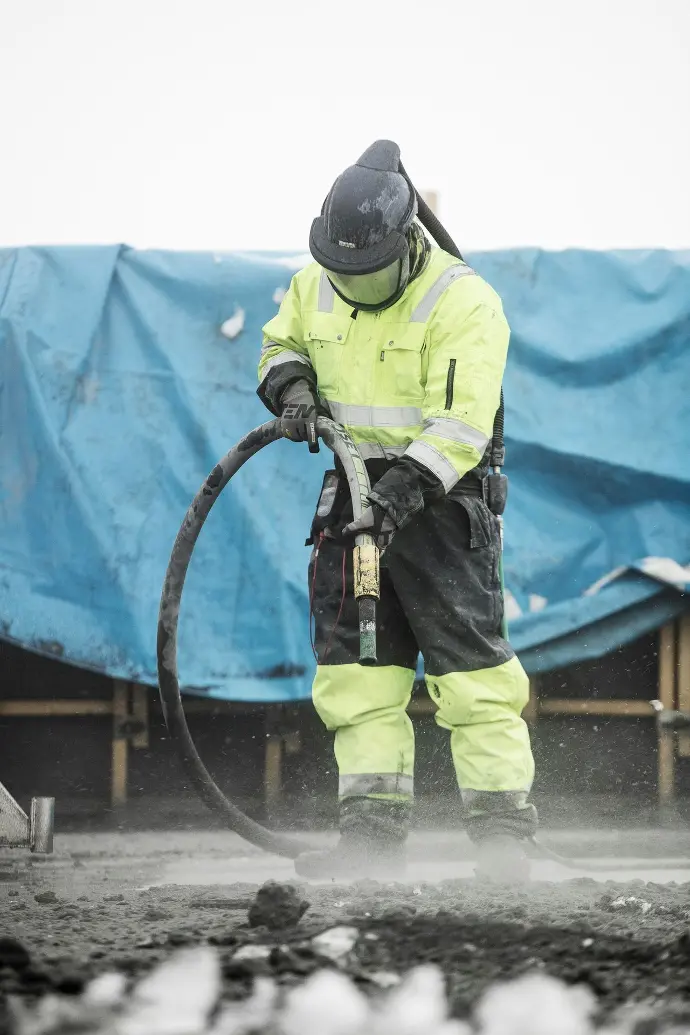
[{"xmin": 157, "ymin": 417, "xmax": 376, "ymax": 859}]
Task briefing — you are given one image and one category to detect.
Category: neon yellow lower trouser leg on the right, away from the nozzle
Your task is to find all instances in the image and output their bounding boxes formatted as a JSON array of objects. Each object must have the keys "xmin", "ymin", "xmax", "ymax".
[{"xmin": 426, "ymin": 657, "xmax": 534, "ymax": 800}]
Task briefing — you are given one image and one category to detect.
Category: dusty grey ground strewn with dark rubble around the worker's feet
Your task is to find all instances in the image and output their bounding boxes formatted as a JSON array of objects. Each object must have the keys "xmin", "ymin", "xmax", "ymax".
[{"xmin": 0, "ymin": 830, "xmax": 690, "ymax": 1015}]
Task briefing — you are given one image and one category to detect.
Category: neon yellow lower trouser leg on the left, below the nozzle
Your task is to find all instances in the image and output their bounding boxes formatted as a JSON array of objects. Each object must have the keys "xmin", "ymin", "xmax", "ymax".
[{"xmin": 312, "ymin": 664, "xmax": 415, "ymax": 801}]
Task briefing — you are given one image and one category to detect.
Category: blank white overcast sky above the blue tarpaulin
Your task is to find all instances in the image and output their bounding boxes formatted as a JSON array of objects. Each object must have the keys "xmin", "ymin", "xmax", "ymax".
[{"xmin": 0, "ymin": 0, "xmax": 690, "ymax": 249}]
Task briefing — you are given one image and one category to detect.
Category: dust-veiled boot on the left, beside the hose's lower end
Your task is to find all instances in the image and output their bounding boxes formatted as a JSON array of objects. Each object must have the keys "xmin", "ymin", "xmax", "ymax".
[{"xmin": 295, "ymin": 798, "xmax": 409, "ymax": 881}]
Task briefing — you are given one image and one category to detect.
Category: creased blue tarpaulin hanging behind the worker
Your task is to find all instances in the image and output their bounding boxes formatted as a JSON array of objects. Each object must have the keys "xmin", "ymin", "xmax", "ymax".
[{"xmin": 0, "ymin": 246, "xmax": 690, "ymax": 701}]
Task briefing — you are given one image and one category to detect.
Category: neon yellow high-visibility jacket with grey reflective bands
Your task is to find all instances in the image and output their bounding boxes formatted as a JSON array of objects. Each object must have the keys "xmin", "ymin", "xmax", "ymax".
[{"xmin": 259, "ymin": 248, "xmax": 510, "ymax": 492}]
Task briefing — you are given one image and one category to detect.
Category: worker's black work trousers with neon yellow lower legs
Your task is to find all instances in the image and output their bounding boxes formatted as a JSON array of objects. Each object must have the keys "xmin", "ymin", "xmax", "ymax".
[{"xmin": 309, "ymin": 493, "xmax": 536, "ymax": 840}]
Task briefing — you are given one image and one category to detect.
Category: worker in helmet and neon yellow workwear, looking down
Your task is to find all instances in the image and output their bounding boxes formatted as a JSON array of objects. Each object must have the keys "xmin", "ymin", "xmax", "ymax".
[{"xmin": 259, "ymin": 141, "xmax": 537, "ymax": 881}]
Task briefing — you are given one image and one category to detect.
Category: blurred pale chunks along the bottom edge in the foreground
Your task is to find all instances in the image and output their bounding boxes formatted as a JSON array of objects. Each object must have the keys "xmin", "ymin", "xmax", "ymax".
[{"xmin": 7, "ymin": 946, "xmax": 690, "ymax": 1035}]
